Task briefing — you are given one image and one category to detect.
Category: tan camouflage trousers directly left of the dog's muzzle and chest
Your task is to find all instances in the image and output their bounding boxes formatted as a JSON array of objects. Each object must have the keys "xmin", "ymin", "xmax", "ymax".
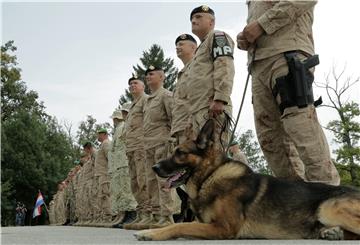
[{"xmin": 145, "ymin": 143, "xmax": 180, "ymax": 216}]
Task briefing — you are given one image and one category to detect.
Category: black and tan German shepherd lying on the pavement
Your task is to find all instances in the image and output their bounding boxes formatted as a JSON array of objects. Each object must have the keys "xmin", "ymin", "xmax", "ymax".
[{"xmin": 135, "ymin": 120, "xmax": 360, "ymax": 240}]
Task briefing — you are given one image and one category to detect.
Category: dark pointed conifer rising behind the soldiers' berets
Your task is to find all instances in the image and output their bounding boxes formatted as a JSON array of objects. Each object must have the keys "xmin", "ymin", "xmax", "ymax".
[{"xmin": 119, "ymin": 44, "xmax": 178, "ymax": 105}]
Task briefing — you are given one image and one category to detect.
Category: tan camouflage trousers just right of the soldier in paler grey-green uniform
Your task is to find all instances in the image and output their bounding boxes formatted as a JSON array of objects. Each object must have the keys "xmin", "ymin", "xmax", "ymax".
[{"xmin": 126, "ymin": 150, "xmax": 148, "ymax": 211}]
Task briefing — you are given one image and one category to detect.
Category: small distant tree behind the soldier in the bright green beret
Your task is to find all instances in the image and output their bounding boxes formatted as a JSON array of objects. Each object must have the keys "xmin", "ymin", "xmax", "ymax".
[{"xmin": 76, "ymin": 115, "xmax": 113, "ymax": 145}]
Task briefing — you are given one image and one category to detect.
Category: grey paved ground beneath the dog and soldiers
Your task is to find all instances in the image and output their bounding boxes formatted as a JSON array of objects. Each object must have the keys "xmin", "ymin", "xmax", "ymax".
[{"xmin": 1, "ymin": 226, "xmax": 360, "ymax": 245}]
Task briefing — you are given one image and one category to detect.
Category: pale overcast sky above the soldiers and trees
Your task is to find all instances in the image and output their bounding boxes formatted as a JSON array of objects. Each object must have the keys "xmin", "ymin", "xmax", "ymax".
[{"xmin": 1, "ymin": 0, "xmax": 360, "ymax": 151}]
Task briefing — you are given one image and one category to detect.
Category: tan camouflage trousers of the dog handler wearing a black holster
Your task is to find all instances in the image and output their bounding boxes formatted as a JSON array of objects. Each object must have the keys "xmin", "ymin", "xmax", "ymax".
[{"xmin": 251, "ymin": 54, "xmax": 340, "ymax": 185}]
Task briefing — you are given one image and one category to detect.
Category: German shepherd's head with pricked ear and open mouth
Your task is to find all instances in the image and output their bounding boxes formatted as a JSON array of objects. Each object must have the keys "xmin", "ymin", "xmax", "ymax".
[{"xmin": 152, "ymin": 119, "xmax": 215, "ymax": 188}]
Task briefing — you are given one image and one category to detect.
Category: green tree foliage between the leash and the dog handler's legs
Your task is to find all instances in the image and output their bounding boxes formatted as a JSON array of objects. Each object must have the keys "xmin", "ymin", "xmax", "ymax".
[{"xmin": 235, "ymin": 129, "xmax": 271, "ymax": 174}]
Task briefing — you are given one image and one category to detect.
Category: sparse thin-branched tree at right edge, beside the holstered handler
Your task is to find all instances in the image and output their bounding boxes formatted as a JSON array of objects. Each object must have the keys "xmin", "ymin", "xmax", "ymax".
[{"xmin": 317, "ymin": 67, "xmax": 360, "ymax": 186}]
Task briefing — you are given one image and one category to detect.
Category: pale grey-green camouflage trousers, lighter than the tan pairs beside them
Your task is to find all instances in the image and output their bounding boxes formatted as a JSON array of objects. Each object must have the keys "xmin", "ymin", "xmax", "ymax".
[{"xmin": 110, "ymin": 166, "xmax": 137, "ymax": 214}]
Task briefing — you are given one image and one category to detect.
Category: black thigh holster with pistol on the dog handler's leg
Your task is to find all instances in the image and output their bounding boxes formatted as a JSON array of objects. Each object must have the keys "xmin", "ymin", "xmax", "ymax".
[{"xmin": 272, "ymin": 51, "xmax": 322, "ymax": 114}]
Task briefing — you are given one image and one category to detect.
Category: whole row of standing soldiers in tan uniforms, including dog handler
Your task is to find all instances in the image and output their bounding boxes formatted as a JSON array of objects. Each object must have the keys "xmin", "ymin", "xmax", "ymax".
[{"xmin": 48, "ymin": 1, "xmax": 340, "ymax": 229}]
